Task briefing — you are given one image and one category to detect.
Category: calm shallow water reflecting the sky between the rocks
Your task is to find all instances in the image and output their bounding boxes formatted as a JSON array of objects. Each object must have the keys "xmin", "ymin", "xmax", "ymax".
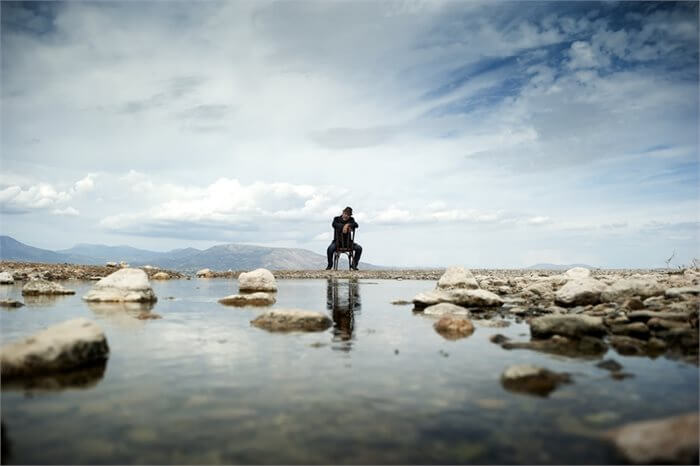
[{"xmin": 0, "ymin": 279, "xmax": 698, "ymax": 464}]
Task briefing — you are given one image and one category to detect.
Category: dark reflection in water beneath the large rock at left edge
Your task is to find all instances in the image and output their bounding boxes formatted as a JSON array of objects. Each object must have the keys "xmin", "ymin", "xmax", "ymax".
[{"xmin": 2, "ymin": 360, "xmax": 107, "ymax": 391}]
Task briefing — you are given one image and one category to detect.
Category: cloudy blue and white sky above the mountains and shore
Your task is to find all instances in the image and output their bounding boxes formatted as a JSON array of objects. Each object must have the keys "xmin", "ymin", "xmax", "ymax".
[{"xmin": 0, "ymin": 0, "xmax": 700, "ymax": 268}]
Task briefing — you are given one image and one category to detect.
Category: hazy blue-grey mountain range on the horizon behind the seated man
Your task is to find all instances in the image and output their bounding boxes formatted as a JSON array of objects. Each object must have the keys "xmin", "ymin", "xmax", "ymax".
[{"xmin": 0, "ymin": 236, "xmax": 383, "ymax": 271}]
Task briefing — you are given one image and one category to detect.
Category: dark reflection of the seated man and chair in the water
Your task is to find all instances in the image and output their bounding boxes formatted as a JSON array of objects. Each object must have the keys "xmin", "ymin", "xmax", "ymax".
[{"xmin": 326, "ymin": 278, "xmax": 362, "ymax": 351}]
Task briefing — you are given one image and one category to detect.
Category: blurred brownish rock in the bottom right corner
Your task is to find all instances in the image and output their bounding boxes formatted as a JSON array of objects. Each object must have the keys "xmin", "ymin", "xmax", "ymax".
[{"xmin": 606, "ymin": 412, "xmax": 698, "ymax": 464}]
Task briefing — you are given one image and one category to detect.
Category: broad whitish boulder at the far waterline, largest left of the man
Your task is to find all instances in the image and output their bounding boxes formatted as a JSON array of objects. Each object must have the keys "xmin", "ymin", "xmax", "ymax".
[{"xmin": 83, "ymin": 268, "xmax": 158, "ymax": 303}]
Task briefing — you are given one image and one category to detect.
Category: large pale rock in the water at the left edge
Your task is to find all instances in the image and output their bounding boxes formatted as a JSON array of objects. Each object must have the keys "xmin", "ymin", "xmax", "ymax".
[{"xmin": 0, "ymin": 318, "xmax": 109, "ymax": 379}]
